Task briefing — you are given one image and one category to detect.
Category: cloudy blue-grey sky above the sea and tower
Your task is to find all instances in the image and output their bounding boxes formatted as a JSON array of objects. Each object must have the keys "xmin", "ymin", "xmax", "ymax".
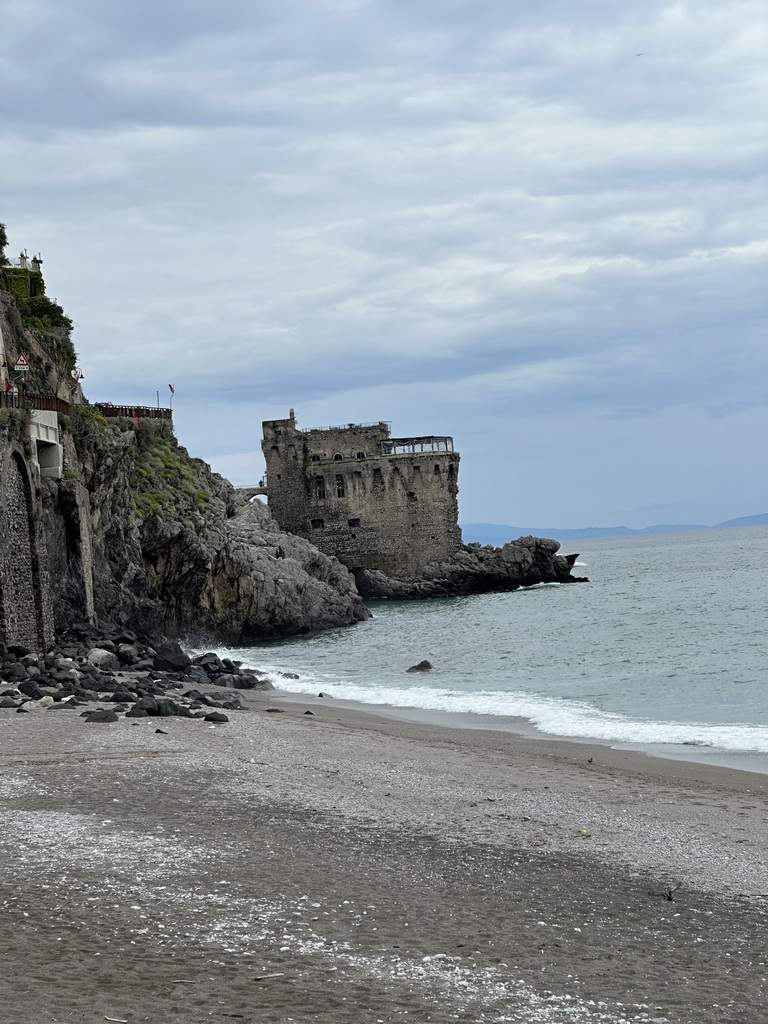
[{"xmin": 0, "ymin": 0, "xmax": 768, "ymax": 527}]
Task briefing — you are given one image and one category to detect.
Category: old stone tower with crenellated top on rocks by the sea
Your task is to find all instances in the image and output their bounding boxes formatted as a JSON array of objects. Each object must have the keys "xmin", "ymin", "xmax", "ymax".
[{"xmin": 261, "ymin": 410, "xmax": 462, "ymax": 580}]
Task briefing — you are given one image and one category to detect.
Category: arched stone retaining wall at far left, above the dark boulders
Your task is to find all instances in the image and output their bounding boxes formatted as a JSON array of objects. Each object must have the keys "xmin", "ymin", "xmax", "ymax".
[{"xmin": 0, "ymin": 442, "xmax": 53, "ymax": 650}]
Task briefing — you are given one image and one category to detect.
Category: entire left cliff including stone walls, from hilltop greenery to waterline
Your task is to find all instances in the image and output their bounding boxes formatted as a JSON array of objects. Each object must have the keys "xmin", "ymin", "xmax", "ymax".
[{"xmin": 0, "ymin": 266, "xmax": 369, "ymax": 646}]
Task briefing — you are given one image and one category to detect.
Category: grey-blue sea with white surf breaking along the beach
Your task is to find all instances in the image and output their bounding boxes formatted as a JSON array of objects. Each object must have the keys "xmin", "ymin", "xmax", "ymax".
[{"xmin": 199, "ymin": 526, "xmax": 768, "ymax": 773}]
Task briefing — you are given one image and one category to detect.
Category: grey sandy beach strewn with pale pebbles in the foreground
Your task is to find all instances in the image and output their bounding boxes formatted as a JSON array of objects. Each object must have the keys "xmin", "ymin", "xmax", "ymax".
[{"xmin": 0, "ymin": 692, "xmax": 768, "ymax": 1024}]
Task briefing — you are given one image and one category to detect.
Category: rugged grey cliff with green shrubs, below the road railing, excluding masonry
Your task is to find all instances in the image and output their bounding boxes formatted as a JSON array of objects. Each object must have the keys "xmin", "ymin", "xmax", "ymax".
[{"xmin": 46, "ymin": 408, "xmax": 368, "ymax": 643}]
